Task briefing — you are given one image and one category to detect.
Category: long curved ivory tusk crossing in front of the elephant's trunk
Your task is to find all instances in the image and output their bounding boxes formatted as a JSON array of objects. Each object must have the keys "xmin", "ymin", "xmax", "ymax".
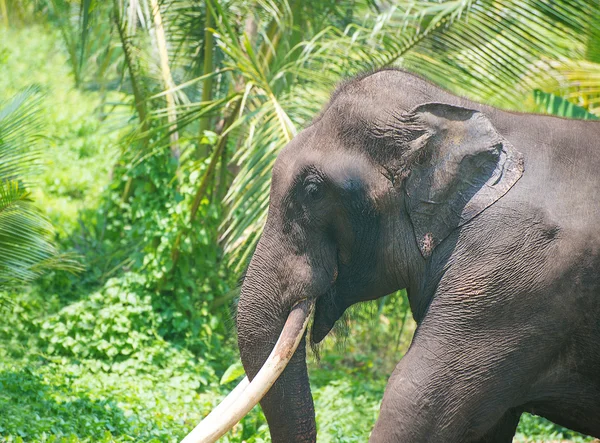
[{"xmin": 181, "ymin": 300, "xmax": 315, "ymax": 443}]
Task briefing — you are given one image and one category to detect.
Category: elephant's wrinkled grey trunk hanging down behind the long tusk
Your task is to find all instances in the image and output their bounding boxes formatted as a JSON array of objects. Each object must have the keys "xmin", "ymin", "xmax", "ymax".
[{"xmin": 237, "ymin": 259, "xmax": 316, "ymax": 443}]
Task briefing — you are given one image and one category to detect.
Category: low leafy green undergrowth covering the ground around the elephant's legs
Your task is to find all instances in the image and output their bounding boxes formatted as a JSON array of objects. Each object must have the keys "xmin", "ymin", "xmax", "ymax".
[{"xmin": 0, "ymin": 292, "xmax": 586, "ymax": 443}]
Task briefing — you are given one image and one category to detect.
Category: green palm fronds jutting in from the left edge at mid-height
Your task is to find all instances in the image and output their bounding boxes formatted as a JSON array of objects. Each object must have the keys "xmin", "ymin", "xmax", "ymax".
[{"xmin": 0, "ymin": 89, "xmax": 78, "ymax": 286}]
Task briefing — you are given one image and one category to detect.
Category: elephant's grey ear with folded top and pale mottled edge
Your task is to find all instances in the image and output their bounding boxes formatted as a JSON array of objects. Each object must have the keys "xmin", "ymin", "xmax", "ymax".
[{"xmin": 405, "ymin": 103, "xmax": 524, "ymax": 257}]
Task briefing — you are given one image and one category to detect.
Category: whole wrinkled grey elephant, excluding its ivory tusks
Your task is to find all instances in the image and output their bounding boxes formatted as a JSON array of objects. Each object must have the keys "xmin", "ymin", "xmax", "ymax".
[{"xmin": 237, "ymin": 70, "xmax": 600, "ymax": 443}]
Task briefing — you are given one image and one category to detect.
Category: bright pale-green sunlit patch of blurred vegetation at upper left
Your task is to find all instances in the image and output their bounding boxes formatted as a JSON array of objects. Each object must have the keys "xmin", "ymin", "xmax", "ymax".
[{"xmin": 0, "ymin": 25, "xmax": 123, "ymax": 238}]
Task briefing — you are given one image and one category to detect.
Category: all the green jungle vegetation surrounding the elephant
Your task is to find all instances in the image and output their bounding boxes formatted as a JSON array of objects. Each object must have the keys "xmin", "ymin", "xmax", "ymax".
[{"xmin": 0, "ymin": 0, "xmax": 600, "ymax": 443}]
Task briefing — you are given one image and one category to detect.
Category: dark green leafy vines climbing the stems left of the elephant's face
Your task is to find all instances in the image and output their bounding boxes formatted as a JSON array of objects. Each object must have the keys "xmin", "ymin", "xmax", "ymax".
[{"xmin": 71, "ymin": 147, "xmax": 237, "ymax": 358}]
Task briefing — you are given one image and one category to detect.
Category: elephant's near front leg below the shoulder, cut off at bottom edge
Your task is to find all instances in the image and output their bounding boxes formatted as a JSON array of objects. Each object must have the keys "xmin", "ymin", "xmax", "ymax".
[{"xmin": 371, "ymin": 300, "xmax": 559, "ymax": 443}]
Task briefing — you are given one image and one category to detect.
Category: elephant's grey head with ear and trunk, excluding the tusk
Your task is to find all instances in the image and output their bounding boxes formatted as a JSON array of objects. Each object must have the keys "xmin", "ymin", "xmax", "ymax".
[{"xmin": 185, "ymin": 71, "xmax": 523, "ymax": 442}]
